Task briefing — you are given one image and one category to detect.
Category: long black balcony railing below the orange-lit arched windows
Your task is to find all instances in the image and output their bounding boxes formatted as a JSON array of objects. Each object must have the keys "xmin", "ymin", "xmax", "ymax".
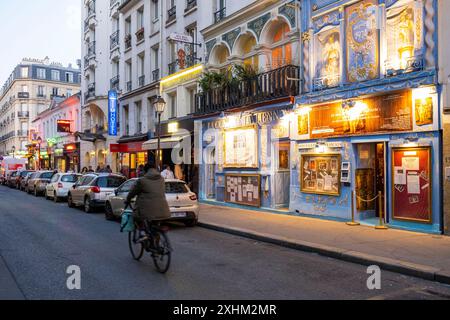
[{"xmin": 195, "ymin": 65, "xmax": 300, "ymax": 114}]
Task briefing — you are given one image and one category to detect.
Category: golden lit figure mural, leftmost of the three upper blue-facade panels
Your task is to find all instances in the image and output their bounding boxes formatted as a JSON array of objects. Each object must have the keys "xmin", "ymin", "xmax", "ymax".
[{"xmin": 315, "ymin": 28, "xmax": 341, "ymax": 86}]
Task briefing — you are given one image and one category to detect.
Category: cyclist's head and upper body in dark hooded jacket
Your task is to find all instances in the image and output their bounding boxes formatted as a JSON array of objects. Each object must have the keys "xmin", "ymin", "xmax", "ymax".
[{"xmin": 126, "ymin": 164, "xmax": 171, "ymax": 221}]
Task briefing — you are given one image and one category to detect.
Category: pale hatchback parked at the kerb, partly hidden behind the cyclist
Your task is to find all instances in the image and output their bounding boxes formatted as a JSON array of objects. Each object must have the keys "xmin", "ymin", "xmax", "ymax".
[{"xmin": 105, "ymin": 179, "xmax": 200, "ymax": 227}]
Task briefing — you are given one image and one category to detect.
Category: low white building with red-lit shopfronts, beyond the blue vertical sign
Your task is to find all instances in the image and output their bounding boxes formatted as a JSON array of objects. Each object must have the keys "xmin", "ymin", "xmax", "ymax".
[{"xmin": 31, "ymin": 92, "xmax": 81, "ymax": 172}]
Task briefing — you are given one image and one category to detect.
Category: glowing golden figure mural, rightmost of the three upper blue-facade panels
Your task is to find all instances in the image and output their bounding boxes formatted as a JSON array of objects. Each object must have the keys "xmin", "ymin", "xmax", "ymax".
[{"xmin": 386, "ymin": 1, "xmax": 423, "ymax": 70}]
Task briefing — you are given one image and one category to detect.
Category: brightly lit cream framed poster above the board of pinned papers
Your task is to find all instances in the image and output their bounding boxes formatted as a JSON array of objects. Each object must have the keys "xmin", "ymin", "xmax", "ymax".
[{"xmin": 223, "ymin": 125, "xmax": 258, "ymax": 168}]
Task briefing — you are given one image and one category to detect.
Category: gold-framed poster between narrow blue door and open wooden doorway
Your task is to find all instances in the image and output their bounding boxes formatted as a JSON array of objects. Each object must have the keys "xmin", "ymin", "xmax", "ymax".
[{"xmin": 300, "ymin": 154, "xmax": 341, "ymax": 196}]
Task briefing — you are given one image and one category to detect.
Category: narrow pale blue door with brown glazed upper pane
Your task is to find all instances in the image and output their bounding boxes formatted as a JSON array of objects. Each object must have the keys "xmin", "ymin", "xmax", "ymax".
[{"xmin": 274, "ymin": 141, "xmax": 291, "ymax": 208}]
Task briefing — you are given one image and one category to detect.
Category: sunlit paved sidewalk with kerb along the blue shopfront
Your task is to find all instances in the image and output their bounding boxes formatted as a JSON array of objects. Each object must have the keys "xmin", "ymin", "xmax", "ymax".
[{"xmin": 199, "ymin": 204, "xmax": 450, "ymax": 284}]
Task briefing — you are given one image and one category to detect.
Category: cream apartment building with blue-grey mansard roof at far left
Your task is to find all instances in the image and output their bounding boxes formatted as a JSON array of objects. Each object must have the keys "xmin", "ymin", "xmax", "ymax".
[{"xmin": 0, "ymin": 57, "xmax": 81, "ymax": 157}]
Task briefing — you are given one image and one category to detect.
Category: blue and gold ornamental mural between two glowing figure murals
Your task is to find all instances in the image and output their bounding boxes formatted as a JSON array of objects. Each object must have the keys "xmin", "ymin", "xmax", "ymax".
[{"xmin": 346, "ymin": 0, "xmax": 379, "ymax": 82}]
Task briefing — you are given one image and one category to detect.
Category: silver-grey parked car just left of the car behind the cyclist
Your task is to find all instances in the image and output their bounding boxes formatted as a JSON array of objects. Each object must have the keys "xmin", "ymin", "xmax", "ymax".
[{"xmin": 67, "ymin": 173, "xmax": 126, "ymax": 213}]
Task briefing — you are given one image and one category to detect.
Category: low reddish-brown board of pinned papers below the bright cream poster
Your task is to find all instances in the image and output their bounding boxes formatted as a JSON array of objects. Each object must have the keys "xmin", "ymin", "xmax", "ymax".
[{"xmin": 225, "ymin": 174, "xmax": 261, "ymax": 207}]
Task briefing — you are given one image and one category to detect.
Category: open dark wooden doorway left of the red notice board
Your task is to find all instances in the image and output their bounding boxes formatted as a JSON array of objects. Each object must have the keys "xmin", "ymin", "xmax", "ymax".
[{"xmin": 355, "ymin": 142, "xmax": 386, "ymax": 224}]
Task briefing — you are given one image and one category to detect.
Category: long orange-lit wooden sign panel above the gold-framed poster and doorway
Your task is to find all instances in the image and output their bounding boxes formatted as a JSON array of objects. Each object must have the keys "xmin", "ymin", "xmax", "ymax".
[{"xmin": 309, "ymin": 90, "xmax": 413, "ymax": 139}]
